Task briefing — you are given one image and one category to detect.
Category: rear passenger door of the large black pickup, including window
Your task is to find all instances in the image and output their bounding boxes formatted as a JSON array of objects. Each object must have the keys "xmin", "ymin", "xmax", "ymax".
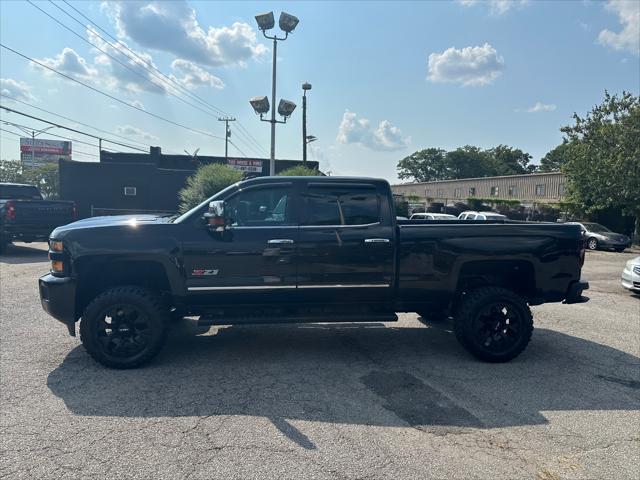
[{"xmin": 298, "ymin": 181, "xmax": 395, "ymax": 303}]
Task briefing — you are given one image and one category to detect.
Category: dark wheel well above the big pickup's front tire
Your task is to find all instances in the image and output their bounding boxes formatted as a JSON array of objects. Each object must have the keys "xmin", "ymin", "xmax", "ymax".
[{"xmin": 76, "ymin": 260, "xmax": 171, "ymax": 317}]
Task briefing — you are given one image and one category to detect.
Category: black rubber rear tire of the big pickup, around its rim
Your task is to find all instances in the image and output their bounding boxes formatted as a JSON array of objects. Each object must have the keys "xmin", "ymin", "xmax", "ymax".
[{"xmin": 453, "ymin": 287, "xmax": 533, "ymax": 363}]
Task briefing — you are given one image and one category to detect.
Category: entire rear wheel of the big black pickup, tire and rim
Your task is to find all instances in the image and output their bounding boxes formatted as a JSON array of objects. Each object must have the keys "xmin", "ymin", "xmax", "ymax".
[{"xmin": 454, "ymin": 287, "xmax": 533, "ymax": 363}]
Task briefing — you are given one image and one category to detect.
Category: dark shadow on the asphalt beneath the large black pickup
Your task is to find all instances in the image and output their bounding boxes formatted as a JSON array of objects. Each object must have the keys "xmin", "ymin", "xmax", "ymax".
[{"xmin": 48, "ymin": 323, "xmax": 640, "ymax": 448}]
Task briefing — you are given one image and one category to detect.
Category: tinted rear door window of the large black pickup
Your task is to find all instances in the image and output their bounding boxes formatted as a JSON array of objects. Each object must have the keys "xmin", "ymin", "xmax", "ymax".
[{"xmin": 301, "ymin": 187, "xmax": 380, "ymax": 225}]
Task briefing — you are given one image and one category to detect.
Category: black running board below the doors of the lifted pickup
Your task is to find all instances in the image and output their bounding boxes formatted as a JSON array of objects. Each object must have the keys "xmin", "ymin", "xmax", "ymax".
[{"xmin": 198, "ymin": 313, "xmax": 398, "ymax": 327}]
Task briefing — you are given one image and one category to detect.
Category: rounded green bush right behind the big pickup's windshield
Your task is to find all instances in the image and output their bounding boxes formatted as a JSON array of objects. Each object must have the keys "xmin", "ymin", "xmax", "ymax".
[{"xmin": 178, "ymin": 163, "xmax": 243, "ymax": 213}]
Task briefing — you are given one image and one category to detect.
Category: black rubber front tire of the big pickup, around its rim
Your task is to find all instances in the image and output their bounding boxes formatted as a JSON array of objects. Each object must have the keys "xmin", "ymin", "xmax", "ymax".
[{"xmin": 80, "ymin": 286, "xmax": 170, "ymax": 369}]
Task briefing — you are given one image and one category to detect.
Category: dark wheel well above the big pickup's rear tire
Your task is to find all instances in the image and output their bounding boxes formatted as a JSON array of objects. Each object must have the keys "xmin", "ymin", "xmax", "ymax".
[{"xmin": 456, "ymin": 260, "xmax": 536, "ymax": 297}]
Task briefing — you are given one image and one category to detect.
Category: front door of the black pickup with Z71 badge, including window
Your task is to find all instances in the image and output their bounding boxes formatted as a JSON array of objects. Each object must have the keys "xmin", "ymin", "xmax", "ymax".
[{"xmin": 183, "ymin": 182, "xmax": 298, "ymax": 305}]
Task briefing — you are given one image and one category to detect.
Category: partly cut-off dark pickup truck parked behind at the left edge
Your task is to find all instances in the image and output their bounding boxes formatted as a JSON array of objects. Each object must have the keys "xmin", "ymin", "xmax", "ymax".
[{"xmin": 0, "ymin": 183, "xmax": 78, "ymax": 253}]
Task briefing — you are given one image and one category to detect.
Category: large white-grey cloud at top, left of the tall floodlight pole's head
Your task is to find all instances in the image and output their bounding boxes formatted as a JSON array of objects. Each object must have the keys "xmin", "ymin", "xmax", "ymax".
[{"xmin": 106, "ymin": 0, "xmax": 267, "ymax": 66}]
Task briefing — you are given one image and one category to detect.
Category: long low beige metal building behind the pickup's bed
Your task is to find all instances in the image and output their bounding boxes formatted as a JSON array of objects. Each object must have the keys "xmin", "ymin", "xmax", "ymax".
[{"xmin": 391, "ymin": 172, "xmax": 565, "ymax": 206}]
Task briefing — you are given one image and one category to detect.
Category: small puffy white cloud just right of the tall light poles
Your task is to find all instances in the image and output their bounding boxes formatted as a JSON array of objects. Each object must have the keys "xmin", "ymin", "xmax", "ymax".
[{"xmin": 337, "ymin": 110, "xmax": 411, "ymax": 150}]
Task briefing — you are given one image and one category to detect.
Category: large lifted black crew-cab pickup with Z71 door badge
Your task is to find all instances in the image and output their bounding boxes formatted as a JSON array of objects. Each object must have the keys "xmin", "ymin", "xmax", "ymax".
[{"xmin": 39, "ymin": 177, "xmax": 588, "ymax": 368}]
